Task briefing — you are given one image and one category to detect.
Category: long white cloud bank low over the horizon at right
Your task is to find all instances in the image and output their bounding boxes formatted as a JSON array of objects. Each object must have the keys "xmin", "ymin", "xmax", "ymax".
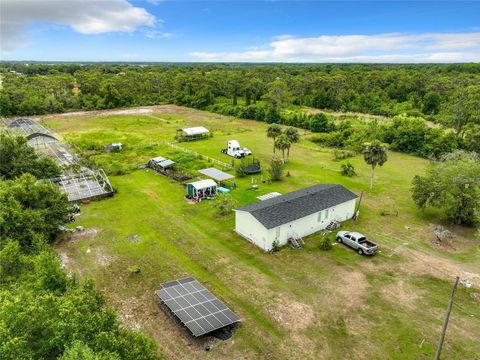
[{"xmin": 190, "ymin": 32, "xmax": 480, "ymax": 62}]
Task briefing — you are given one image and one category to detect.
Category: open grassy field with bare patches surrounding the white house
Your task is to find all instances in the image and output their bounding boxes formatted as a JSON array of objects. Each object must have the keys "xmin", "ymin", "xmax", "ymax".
[{"xmin": 42, "ymin": 106, "xmax": 480, "ymax": 359}]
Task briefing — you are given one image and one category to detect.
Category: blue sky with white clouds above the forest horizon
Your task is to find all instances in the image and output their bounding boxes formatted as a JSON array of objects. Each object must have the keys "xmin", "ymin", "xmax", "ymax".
[{"xmin": 0, "ymin": 0, "xmax": 480, "ymax": 63}]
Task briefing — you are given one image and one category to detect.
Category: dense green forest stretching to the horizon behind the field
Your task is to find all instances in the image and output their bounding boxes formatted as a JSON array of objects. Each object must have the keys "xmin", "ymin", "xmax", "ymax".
[{"xmin": 0, "ymin": 63, "xmax": 480, "ymax": 158}]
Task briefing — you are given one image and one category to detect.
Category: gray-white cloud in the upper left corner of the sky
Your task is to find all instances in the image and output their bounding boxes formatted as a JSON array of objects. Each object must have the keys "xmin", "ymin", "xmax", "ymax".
[{"xmin": 0, "ymin": 0, "xmax": 156, "ymax": 53}]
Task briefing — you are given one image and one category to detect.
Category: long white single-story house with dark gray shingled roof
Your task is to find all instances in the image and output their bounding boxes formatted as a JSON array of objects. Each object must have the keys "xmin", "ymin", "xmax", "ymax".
[{"xmin": 234, "ymin": 184, "xmax": 358, "ymax": 251}]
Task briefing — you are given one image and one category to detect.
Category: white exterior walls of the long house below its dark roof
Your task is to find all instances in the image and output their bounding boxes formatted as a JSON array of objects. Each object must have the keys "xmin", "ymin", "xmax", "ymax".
[{"xmin": 235, "ymin": 199, "xmax": 356, "ymax": 251}]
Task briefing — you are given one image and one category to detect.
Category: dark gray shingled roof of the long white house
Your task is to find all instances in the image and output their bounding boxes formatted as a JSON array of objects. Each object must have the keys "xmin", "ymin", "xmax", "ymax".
[{"xmin": 235, "ymin": 184, "xmax": 358, "ymax": 229}]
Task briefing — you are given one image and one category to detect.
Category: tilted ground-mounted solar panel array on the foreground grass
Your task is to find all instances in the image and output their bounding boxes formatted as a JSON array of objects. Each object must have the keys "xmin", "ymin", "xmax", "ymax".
[{"xmin": 156, "ymin": 277, "xmax": 240, "ymax": 337}]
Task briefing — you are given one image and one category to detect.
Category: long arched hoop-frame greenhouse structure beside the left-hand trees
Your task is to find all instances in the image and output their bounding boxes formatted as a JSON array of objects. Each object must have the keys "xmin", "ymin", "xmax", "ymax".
[{"xmin": 4, "ymin": 118, "xmax": 113, "ymax": 201}]
